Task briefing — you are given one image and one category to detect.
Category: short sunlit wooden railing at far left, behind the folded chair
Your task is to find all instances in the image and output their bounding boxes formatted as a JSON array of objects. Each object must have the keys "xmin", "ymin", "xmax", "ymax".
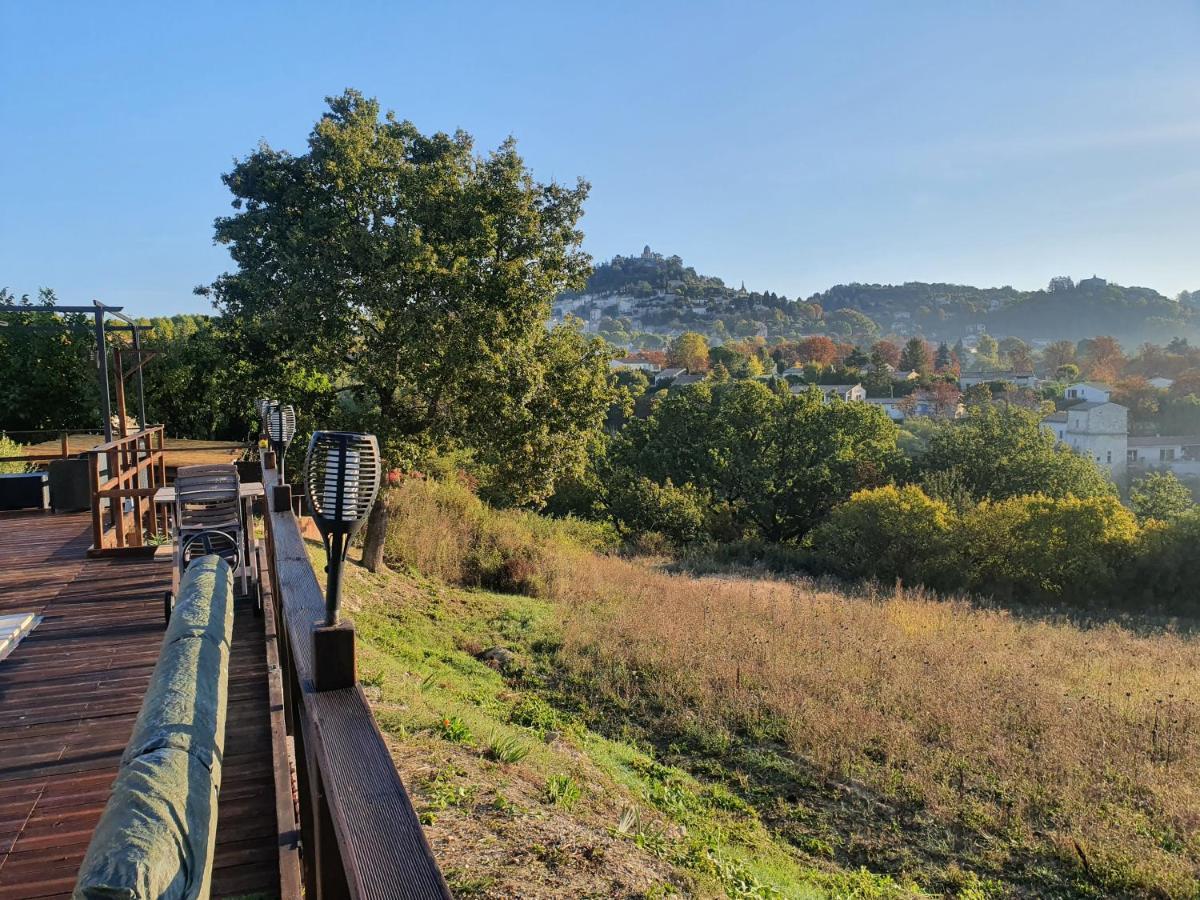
[{"xmin": 88, "ymin": 425, "xmax": 167, "ymax": 556}]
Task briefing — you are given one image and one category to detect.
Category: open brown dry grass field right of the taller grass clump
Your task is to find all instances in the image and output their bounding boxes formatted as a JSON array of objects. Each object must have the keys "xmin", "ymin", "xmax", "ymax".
[{"xmin": 560, "ymin": 556, "xmax": 1200, "ymax": 896}]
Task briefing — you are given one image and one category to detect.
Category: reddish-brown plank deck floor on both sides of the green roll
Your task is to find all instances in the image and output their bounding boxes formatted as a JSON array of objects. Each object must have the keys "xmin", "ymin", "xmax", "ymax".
[{"xmin": 0, "ymin": 512, "xmax": 281, "ymax": 900}]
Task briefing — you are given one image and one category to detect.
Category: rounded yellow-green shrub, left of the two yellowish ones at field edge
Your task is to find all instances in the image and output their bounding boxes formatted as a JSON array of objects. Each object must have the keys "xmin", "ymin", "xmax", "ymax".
[{"xmin": 811, "ymin": 485, "xmax": 956, "ymax": 588}]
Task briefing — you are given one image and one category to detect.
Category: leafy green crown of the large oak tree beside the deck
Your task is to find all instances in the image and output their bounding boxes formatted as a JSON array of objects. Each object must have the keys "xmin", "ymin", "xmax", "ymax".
[{"xmin": 202, "ymin": 90, "xmax": 612, "ymax": 566}]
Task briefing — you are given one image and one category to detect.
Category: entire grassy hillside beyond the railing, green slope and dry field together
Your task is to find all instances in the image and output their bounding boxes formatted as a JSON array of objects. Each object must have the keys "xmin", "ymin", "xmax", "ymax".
[{"xmin": 340, "ymin": 480, "xmax": 1200, "ymax": 898}]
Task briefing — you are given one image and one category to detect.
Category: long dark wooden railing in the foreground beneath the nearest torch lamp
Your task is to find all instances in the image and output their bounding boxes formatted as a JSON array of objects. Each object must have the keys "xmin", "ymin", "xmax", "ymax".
[{"xmin": 263, "ymin": 461, "xmax": 450, "ymax": 900}]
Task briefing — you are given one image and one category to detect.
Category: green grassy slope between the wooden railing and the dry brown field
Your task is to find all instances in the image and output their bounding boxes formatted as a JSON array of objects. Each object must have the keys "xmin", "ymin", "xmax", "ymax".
[{"xmin": 336, "ymin": 549, "xmax": 916, "ymax": 898}]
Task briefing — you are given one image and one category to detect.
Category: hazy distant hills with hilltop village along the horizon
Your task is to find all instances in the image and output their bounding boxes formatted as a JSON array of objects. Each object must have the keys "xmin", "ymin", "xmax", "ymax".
[{"xmin": 554, "ymin": 246, "xmax": 1200, "ymax": 347}]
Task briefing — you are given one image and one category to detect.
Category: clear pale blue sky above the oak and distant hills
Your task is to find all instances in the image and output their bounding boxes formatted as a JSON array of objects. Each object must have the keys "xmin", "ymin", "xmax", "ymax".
[{"xmin": 0, "ymin": 0, "xmax": 1200, "ymax": 314}]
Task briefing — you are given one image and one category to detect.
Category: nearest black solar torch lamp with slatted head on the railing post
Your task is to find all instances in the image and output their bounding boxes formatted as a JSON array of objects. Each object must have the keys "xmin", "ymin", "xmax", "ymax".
[{"xmin": 304, "ymin": 431, "xmax": 382, "ymax": 629}]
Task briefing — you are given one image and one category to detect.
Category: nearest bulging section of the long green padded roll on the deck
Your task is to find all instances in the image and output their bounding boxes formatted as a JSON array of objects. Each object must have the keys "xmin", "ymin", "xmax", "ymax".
[{"xmin": 74, "ymin": 749, "xmax": 217, "ymax": 900}]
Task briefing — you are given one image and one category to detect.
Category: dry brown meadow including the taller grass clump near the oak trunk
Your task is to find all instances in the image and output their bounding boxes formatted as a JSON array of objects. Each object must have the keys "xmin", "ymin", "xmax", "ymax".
[{"xmin": 372, "ymin": 481, "xmax": 1200, "ymax": 898}]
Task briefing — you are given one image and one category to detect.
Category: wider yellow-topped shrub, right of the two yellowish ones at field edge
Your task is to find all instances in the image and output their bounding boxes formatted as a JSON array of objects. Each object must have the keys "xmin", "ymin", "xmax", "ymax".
[{"xmin": 961, "ymin": 494, "xmax": 1138, "ymax": 606}]
